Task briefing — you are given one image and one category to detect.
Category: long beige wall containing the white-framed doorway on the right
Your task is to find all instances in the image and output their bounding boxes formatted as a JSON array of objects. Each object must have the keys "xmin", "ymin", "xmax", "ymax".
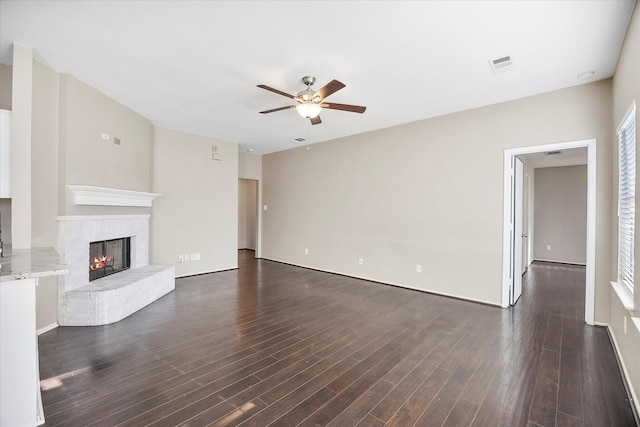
[{"xmin": 262, "ymin": 80, "xmax": 612, "ymax": 310}]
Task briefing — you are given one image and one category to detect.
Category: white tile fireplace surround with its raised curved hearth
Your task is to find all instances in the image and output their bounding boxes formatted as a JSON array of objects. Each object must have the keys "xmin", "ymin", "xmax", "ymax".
[{"xmin": 58, "ymin": 215, "xmax": 175, "ymax": 326}]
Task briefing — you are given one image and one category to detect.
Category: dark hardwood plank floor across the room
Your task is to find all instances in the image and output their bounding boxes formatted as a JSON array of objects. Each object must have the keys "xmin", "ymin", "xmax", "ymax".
[{"xmin": 39, "ymin": 251, "xmax": 635, "ymax": 427}]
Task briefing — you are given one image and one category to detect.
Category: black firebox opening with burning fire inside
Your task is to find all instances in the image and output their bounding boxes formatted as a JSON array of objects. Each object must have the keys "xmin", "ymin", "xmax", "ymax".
[{"xmin": 89, "ymin": 237, "xmax": 131, "ymax": 281}]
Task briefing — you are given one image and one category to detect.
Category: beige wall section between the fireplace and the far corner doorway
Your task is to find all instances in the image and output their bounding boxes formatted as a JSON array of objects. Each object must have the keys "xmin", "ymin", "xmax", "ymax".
[{"xmin": 151, "ymin": 128, "xmax": 238, "ymax": 277}]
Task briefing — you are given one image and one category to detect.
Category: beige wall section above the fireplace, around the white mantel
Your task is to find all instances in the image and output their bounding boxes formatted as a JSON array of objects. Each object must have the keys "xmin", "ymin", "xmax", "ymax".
[{"xmin": 58, "ymin": 74, "xmax": 151, "ymax": 215}]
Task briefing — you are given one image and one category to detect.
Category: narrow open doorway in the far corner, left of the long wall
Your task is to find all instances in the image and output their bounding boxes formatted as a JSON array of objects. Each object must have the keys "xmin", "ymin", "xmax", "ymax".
[{"xmin": 238, "ymin": 179, "xmax": 258, "ymax": 251}]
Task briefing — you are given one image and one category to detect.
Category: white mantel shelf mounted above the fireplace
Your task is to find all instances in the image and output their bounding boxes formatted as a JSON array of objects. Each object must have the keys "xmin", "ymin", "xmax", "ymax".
[{"xmin": 67, "ymin": 185, "xmax": 160, "ymax": 208}]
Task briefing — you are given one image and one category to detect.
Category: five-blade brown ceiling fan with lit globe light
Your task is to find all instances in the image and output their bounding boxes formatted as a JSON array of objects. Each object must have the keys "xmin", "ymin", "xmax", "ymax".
[{"xmin": 257, "ymin": 76, "xmax": 367, "ymax": 125}]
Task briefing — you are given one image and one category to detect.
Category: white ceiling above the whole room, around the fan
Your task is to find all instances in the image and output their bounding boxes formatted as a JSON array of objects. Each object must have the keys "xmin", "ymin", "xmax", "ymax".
[{"xmin": 0, "ymin": 0, "xmax": 635, "ymax": 153}]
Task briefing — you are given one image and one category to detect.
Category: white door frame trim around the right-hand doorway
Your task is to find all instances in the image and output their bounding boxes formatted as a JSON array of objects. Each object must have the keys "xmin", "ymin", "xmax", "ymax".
[{"xmin": 502, "ymin": 138, "xmax": 596, "ymax": 325}]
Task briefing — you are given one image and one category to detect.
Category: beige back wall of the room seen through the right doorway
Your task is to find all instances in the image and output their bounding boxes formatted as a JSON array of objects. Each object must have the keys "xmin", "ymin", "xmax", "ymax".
[{"xmin": 533, "ymin": 165, "xmax": 587, "ymax": 264}]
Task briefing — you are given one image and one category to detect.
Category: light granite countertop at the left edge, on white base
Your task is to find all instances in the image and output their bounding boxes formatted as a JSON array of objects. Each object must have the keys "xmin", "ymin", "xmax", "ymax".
[{"xmin": 0, "ymin": 245, "xmax": 69, "ymax": 282}]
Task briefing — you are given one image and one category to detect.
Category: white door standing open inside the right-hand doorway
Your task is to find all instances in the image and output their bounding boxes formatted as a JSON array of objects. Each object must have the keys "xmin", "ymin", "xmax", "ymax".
[{"xmin": 510, "ymin": 156, "xmax": 524, "ymax": 305}]
